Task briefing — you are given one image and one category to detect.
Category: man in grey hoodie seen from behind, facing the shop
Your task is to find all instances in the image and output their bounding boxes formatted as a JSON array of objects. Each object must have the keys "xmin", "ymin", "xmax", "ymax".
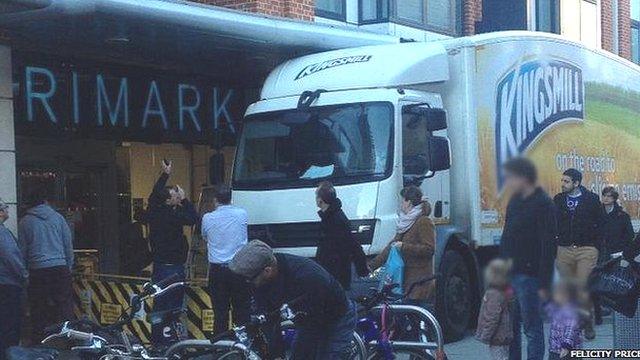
[{"xmin": 18, "ymin": 187, "xmax": 73, "ymax": 341}]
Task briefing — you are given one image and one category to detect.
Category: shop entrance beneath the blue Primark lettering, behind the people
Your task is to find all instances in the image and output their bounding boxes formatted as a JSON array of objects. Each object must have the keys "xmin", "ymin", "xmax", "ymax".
[{"xmin": 16, "ymin": 137, "xmax": 228, "ymax": 276}]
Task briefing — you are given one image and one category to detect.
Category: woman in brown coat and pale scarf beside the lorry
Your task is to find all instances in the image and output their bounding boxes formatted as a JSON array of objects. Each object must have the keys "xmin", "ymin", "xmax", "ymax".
[{"xmin": 369, "ymin": 185, "xmax": 436, "ymax": 306}]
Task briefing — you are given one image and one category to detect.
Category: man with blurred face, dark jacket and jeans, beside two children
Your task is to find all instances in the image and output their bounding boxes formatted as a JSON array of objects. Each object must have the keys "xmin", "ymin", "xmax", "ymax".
[{"xmin": 500, "ymin": 158, "xmax": 556, "ymax": 360}]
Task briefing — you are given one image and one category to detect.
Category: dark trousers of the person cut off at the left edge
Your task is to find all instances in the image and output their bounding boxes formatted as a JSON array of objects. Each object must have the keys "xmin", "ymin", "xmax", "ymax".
[{"xmin": 0, "ymin": 284, "xmax": 22, "ymax": 360}]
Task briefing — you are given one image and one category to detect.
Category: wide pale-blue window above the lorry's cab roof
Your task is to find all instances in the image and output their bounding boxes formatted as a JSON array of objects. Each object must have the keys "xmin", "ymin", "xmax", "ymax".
[{"xmin": 359, "ymin": 0, "xmax": 460, "ymax": 35}]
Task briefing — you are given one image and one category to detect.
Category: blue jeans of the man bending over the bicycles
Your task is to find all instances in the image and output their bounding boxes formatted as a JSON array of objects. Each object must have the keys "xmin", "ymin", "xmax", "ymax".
[{"xmin": 291, "ymin": 302, "xmax": 356, "ymax": 360}]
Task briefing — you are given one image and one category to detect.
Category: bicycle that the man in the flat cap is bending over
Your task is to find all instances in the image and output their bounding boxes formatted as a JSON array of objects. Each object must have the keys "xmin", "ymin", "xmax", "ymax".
[{"xmin": 166, "ymin": 299, "xmax": 367, "ymax": 360}]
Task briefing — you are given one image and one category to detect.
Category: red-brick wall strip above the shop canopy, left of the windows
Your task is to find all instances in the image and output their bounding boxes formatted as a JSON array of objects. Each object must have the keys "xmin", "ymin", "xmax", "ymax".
[{"xmin": 192, "ymin": 0, "xmax": 315, "ymax": 21}]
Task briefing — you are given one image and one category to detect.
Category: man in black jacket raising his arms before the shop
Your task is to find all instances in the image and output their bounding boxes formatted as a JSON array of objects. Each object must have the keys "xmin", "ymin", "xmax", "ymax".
[{"xmin": 145, "ymin": 160, "xmax": 198, "ymax": 345}]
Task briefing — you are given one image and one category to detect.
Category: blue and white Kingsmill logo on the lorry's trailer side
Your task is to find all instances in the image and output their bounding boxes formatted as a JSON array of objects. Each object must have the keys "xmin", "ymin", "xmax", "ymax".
[{"xmin": 495, "ymin": 59, "xmax": 584, "ymax": 190}]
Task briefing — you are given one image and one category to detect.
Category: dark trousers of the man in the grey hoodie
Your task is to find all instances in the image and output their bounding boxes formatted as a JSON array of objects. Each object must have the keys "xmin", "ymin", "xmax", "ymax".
[{"xmin": 28, "ymin": 266, "xmax": 74, "ymax": 343}]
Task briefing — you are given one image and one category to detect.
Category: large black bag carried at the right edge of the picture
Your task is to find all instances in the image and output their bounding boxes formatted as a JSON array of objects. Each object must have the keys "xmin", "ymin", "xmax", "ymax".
[{"xmin": 587, "ymin": 257, "xmax": 640, "ymax": 317}]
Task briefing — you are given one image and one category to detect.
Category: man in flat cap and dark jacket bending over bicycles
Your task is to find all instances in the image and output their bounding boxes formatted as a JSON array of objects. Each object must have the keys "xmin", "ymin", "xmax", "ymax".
[{"xmin": 229, "ymin": 240, "xmax": 356, "ymax": 360}]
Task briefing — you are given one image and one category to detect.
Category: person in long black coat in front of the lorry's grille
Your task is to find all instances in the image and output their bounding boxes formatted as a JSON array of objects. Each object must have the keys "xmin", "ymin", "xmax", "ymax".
[{"xmin": 316, "ymin": 181, "xmax": 369, "ymax": 290}]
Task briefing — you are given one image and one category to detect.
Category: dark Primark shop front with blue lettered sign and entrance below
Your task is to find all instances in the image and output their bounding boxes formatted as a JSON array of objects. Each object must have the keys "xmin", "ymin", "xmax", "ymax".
[{"xmin": 13, "ymin": 51, "xmax": 249, "ymax": 275}]
